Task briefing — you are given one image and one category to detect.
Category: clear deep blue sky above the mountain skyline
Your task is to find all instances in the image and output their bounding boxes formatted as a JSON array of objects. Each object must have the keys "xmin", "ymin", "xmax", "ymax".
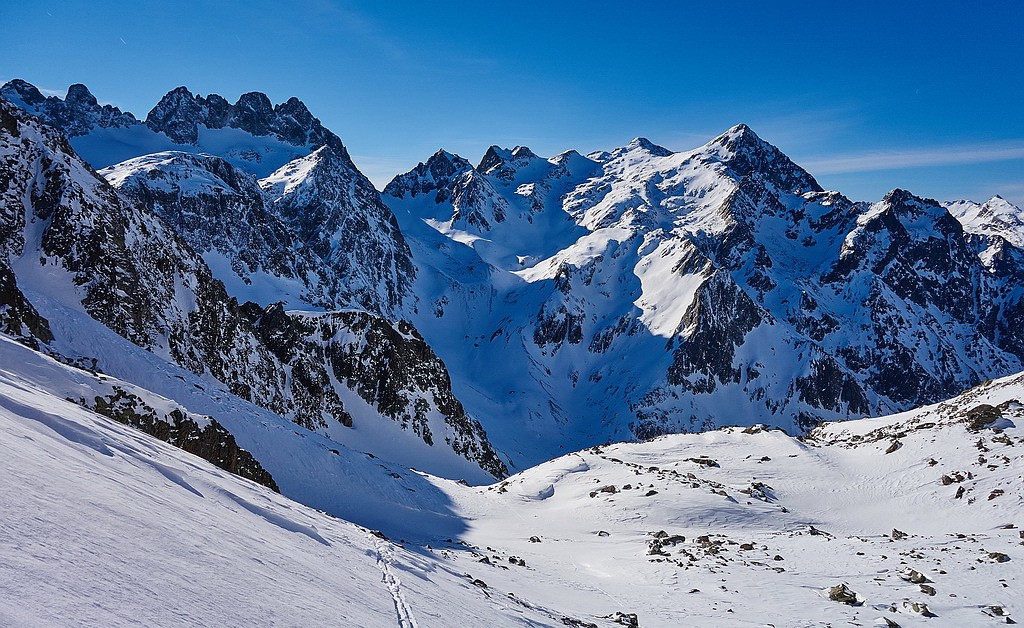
[{"xmin": 0, "ymin": 0, "xmax": 1024, "ymax": 202}]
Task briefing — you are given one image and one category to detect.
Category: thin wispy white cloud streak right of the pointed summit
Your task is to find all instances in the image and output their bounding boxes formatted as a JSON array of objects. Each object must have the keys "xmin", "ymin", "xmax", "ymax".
[{"xmin": 801, "ymin": 140, "xmax": 1024, "ymax": 174}]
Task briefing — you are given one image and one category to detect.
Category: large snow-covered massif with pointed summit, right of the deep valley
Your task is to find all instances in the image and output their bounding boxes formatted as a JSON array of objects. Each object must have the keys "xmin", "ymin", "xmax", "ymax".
[{"xmin": 384, "ymin": 125, "xmax": 1024, "ymax": 462}]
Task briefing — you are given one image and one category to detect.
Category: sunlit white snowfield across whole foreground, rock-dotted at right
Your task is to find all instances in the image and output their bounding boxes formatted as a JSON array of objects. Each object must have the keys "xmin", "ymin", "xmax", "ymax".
[{"xmin": 0, "ymin": 333, "xmax": 1024, "ymax": 627}]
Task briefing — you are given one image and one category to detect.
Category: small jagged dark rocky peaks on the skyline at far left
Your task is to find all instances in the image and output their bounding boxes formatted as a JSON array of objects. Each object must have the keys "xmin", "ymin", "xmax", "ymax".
[{"xmin": 0, "ymin": 79, "xmax": 138, "ymax": 137}]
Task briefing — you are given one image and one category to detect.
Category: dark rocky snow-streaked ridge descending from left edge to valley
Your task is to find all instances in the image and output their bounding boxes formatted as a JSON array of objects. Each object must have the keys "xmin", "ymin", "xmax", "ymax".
[{"xmin": 0, "ymin": 90, "xmax": 507, "ymax": 482}]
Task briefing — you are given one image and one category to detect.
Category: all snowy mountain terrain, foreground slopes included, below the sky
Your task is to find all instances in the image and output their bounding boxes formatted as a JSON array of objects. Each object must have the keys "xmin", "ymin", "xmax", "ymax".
[{"xmin": 0, "ymin": 80, "xmax": 1024, "ymax": 628}]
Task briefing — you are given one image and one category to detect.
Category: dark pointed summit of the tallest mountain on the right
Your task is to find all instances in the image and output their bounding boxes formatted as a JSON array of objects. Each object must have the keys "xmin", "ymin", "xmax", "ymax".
[{"xmin": 693, "ymin": 124, "xmax": 824, "ymax": 194}]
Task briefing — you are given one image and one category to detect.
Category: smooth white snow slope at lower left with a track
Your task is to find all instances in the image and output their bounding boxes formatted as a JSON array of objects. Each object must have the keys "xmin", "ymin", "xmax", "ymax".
[{"xmin": 0, "ymin": 338, "xmax": 577, "ymax": 627}]
